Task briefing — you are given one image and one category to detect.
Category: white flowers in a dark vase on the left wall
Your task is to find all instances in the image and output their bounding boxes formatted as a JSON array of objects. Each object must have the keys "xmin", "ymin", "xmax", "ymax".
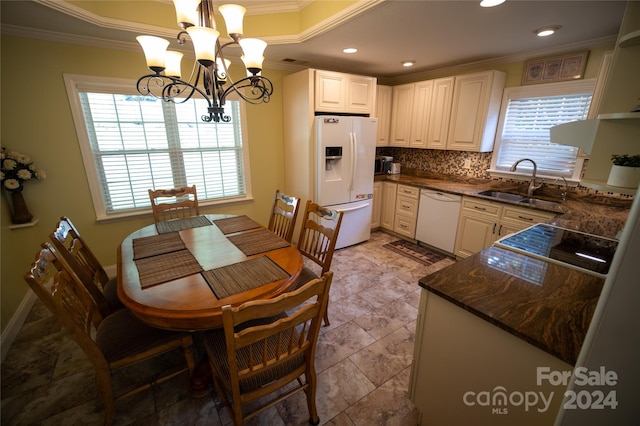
[{"xmin": 0, "ymin": 147, "xmax": 47, "ymax": 224}]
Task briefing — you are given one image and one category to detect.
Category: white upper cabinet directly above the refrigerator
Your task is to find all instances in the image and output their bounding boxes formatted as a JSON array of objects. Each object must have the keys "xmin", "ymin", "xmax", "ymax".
[{"xmin": 315, "ymin": 70, "xmax": 376, "ymax": 115}]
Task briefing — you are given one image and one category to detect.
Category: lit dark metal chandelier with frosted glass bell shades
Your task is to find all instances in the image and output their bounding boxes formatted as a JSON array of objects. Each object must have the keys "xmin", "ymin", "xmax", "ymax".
[{"xmin": 136, "ymin": 0, "xmax": 273, "ymax": 123}]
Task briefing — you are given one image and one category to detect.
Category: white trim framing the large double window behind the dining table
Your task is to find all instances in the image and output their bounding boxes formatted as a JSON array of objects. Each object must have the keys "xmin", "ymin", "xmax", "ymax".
[{"xmin": 63, "ymin": 74, "xmax": 254, "ymax": 221}]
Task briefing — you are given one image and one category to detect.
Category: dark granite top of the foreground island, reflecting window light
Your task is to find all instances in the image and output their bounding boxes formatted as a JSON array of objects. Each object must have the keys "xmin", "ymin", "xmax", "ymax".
[{"xmin": 420, "ymin": 247, "xmax": 604, "ymax": 365}]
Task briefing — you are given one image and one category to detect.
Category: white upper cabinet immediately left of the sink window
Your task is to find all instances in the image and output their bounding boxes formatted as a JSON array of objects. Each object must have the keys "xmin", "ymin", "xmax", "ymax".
[{"xmin": 447, "ymin": 70, "xmax": 505, "ymax": 152}]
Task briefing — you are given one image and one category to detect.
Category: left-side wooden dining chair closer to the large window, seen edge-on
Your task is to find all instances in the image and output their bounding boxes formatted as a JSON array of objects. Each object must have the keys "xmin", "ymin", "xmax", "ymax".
[{"xmin": 49, "ymin": 216, "xmax": 124, "ymax": 317}]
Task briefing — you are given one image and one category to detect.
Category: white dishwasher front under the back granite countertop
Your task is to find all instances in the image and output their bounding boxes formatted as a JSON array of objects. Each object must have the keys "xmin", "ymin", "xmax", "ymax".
[{"xmin": 416, "ymin": 189, "xmax": 462, "ymax": 253}]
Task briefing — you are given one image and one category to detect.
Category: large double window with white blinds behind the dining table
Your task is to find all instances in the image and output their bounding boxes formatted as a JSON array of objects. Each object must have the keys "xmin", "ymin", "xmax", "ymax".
[{"xmin": 63, "ymin": 74, "xmax": 247, "ymax": 218}]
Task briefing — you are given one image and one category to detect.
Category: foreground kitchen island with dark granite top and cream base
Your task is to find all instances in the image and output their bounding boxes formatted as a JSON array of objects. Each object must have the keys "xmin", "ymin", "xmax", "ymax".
[{"xmin": 410, "ymin": 247, "xmax": 604, "ymax": 426}]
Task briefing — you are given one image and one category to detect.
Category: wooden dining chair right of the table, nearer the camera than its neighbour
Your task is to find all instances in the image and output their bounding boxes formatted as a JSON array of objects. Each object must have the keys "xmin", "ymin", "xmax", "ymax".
[{"xmin": 297, "ymin": 200, "xmax": 344, "ymax": 325}]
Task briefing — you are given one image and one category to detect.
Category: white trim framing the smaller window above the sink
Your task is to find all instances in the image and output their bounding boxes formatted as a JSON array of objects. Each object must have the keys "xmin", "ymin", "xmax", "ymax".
[{"xmin": 488, "ymin": 78, "xmax": 596, "ymax": 186}]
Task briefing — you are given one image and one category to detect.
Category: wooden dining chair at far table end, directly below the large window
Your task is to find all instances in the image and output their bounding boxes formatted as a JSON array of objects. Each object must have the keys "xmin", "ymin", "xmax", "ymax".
[{"xmin": 149, "ymin": 185, "xmax": 200, "ymax": 223}]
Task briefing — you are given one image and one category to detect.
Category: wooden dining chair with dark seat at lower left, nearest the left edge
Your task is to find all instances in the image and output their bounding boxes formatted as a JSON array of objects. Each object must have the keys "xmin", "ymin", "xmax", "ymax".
[{"xmin": 24, "ymin": 243, "xmax": 194, "ymax": 425}]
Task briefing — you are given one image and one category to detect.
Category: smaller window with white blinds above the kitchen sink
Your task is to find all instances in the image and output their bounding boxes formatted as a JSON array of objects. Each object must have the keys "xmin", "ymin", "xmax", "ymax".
[{"xmin": 492, "ymin": 81, "xmax": 593, "ymax": 179}]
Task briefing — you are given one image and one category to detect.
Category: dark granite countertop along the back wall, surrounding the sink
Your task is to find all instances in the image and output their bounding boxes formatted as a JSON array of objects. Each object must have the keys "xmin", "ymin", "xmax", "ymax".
[{"xmin": 375, "ymin": 170, "xmax": 633, "ymax": 238}]
